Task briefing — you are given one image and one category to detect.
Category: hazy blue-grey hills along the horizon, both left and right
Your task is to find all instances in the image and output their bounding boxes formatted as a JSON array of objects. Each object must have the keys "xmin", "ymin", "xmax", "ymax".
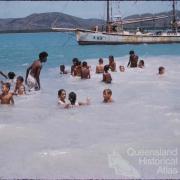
[{"xmin": 0, "ymin": 11, "xmax": 180, "ymax": 32}]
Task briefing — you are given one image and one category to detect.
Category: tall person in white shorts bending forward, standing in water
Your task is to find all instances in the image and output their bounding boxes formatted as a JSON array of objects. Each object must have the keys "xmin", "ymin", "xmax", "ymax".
[{"xmin": 25, "ymin": 51, "xmax": 48, "ymax": 90}]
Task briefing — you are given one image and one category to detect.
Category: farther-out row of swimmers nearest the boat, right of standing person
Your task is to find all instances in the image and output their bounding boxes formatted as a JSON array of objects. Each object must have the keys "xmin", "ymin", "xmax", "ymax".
[{"xmin": 60, "ymin": 50, "xmax": 165, "ymax": 83}]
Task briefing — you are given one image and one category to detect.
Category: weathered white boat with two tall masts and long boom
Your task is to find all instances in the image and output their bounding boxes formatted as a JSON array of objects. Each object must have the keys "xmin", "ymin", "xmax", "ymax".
[{"xmin": 75, "ymin": 0, "xmax": 180, "ymax": 45}]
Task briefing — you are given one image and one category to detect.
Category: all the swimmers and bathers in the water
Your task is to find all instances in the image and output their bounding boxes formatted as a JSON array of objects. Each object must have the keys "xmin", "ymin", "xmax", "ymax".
[{"xmin": 0, "ymin": 50, "xmax": 165, "ymax": 108}]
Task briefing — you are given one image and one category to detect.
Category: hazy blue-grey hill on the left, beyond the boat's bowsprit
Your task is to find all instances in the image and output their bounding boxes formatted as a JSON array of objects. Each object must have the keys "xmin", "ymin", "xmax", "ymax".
[{"xmin": 0, "ymin": 12, "xmax": 105, "ymax": 31}]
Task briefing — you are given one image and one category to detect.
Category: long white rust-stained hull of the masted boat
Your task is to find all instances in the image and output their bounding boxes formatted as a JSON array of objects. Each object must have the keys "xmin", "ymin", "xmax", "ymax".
[{"xmin": 76, "ymin": 30, "xmax": 180, "ymax": 45}]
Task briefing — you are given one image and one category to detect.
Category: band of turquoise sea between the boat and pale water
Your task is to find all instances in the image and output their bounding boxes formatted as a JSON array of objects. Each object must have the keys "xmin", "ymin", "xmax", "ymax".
[{"xmin": 0, "ymin": 33, "xmax": 180, "ymax": 72}]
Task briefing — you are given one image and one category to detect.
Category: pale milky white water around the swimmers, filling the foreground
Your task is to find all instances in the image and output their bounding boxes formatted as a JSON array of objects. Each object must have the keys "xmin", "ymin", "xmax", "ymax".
[{"xmin": 0, "ymin": 56, "xmax": 180, "ymax": 178}]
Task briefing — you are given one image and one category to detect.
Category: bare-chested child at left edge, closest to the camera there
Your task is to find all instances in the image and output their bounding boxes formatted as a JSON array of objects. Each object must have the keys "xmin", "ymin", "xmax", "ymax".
[{"xmin": 0, "ymin": 83, "xmax": 14, "ymax": 104}]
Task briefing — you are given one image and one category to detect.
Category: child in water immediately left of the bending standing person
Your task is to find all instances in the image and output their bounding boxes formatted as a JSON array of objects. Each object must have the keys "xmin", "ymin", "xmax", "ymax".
[{"xmin": 14, "ymin": 76, "xmax": 26, "ymax": 95}]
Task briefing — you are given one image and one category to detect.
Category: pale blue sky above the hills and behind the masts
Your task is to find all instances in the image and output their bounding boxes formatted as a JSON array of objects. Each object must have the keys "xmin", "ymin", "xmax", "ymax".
[{"xmin": 0, "ymin": 1, "xmax": 180, "ymax": 19}]
